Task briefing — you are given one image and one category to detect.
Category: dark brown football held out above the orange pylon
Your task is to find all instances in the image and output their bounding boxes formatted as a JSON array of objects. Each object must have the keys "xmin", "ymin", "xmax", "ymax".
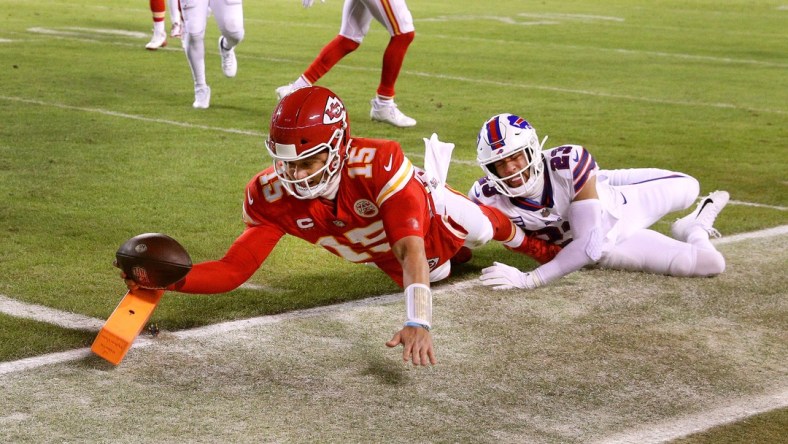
[{"xmin": 115, "ymin": 233, "xmax": 192, "ymax": 289}]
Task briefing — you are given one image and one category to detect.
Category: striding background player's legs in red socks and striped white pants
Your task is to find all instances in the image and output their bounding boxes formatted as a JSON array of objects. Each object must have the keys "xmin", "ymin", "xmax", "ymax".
[{"xmin": 276, "ymin": 0, "xmax": 416, "ymax": 127}]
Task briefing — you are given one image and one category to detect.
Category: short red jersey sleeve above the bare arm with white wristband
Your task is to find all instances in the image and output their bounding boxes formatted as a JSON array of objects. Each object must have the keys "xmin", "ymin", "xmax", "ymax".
[{"xmin": 380, "ymin": 178, "xmax": 428, "ymax": 245}]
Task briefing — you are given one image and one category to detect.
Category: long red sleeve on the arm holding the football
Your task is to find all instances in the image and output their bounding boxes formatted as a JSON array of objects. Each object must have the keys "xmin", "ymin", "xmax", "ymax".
[{"xmin": 168, "ymin": 224, "xmax": 284, "ymax": 294}]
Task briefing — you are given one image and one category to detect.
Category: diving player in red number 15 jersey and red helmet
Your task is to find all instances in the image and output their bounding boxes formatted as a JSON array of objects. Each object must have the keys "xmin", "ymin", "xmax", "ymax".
[{"xmin": 118, "ymin": 86, "xmax": 556, "ymax": 365}]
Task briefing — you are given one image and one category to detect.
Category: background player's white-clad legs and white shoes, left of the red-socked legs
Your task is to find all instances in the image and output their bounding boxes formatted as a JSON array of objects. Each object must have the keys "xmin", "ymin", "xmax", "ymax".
[{"xmin": 181, "ymin": 0, "xmax": 244, "ymax": 109}]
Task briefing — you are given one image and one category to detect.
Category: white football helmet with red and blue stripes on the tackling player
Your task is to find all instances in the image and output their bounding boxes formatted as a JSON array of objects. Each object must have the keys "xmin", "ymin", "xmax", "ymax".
[{"xmin": 476, "ymin": 114, "xmax": 547, "ymax": 199}]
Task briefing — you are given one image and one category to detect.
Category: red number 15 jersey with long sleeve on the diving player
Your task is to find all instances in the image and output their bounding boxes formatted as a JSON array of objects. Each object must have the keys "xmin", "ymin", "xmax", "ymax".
[{"xmin": 173, "ymin": 139, "xmax": 465, "ymax": 293}]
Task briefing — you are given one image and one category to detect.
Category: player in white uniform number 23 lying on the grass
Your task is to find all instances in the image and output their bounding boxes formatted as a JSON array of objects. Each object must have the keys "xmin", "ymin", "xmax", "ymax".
[{"xmin": 469, "ymin": 114, "xmax": 729, "ymax": 290}]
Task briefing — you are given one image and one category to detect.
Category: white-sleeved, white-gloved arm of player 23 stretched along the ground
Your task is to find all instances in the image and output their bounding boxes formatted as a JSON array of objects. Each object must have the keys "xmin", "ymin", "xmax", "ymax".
[{"xmin": 481, "ymin": 177, "xmax": 603, "ymax": 290}]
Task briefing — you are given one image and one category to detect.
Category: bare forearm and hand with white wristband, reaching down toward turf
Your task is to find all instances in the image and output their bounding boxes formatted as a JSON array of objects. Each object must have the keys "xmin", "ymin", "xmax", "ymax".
[{"xmin": 386, "ymin": 236, "xmax": 438, "ymax": 365}]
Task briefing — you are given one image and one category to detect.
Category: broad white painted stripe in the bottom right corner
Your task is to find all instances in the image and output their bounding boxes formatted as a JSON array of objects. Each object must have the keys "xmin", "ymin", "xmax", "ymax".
[{"xmin": 599, "ymin": 389, "xmax": 788, "ymax": 444}]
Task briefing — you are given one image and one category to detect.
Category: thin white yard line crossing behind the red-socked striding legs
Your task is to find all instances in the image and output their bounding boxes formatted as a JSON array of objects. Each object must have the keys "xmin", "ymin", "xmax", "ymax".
[{"xmin": 16, "ymin": 28, "xmax": 788, "ymax": 115}]
